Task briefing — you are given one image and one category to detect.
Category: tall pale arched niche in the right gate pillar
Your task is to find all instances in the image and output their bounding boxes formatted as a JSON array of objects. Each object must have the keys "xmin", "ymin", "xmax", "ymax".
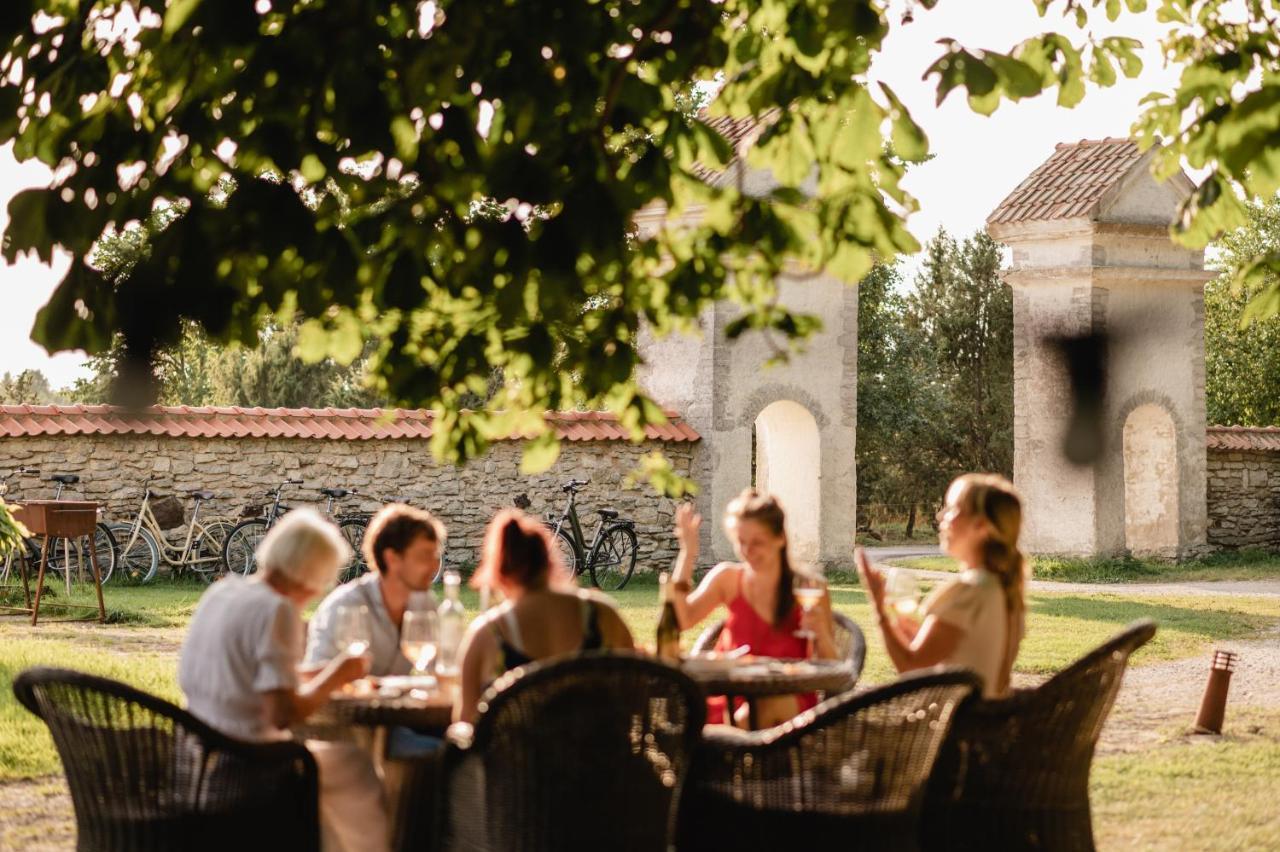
[{"xmin": 1124, "ymin": 403, "xmax": 1178, "ymax": 556}]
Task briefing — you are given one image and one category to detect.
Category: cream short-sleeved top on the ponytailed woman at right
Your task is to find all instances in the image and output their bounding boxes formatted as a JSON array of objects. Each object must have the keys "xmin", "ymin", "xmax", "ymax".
[{"xmin": 922, "ymin": 568, "xmax": 1025, "ymax": 698}]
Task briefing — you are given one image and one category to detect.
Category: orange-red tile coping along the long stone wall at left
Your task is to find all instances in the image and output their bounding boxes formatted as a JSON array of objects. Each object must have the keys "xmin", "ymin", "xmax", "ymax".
[{"xmin": 0, "ymin": 406, "xmax": 699, "ymax": 441}]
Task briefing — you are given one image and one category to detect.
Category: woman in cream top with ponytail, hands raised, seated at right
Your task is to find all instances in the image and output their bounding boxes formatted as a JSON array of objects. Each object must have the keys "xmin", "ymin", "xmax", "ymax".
[{"xmin": 858, "ymin": 473, "xmax": 1027, "ymax": 698}]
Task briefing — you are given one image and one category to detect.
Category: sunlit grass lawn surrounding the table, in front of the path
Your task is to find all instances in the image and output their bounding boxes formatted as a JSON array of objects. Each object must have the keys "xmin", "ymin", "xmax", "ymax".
[{"xmin": 0, "ymin": 576, "xmax": 1280, "ymax": 849}]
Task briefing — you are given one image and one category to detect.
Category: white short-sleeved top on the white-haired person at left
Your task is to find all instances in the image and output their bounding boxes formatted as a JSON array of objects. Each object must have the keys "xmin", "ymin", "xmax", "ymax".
[{"xmin": 178, "ymin": 574, "xmax": 303, "ymax": 741}]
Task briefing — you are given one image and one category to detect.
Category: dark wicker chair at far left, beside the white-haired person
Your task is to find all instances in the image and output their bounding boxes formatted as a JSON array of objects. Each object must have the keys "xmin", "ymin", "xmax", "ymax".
[{"xmin": 13, "ymin": 668, "xmax": 320, "ymax": 852}]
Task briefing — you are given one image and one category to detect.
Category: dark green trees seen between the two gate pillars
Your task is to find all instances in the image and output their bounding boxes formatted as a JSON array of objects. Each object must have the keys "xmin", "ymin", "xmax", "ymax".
[{"xmin": 858, "ymin": 230, "xmax": 1014, "ymax": 535}]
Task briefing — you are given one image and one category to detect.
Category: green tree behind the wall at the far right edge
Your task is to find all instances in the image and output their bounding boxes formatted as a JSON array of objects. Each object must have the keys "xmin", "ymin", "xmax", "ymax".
[{"xmin": 1204, "ymin": 197, "xmax": 1280, "ymax": 426}]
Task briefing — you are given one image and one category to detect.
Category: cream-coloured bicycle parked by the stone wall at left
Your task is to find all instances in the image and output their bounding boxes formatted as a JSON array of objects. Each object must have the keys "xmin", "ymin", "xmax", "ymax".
[{"xmin": 110, "ymin": 478, "xmax": 236, "ymax": 586}]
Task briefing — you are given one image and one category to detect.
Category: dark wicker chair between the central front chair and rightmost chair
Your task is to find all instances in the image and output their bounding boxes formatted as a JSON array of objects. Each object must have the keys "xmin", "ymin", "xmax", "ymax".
[{"xmin": 676, "ymin": 670, "xmax": 978, "ymax": 852}]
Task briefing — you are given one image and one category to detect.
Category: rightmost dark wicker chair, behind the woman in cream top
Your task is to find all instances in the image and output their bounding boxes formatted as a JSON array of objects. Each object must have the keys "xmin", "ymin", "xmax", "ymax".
[{"xmin": 923, "ymin": 620, "xmax": 1156, "ymax": 851}]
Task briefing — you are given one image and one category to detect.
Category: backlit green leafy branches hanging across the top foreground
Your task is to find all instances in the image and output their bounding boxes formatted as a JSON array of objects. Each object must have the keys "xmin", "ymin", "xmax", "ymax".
[{"xmin": 0, "ymin": 0, "xmax": 1280, "ymax": 478}]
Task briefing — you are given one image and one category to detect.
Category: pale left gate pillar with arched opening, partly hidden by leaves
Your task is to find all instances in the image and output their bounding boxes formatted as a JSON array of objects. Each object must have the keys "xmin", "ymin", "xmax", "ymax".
[{"xmin": 639, "ymin": 268, "xmax": 858, "ymax": 569}]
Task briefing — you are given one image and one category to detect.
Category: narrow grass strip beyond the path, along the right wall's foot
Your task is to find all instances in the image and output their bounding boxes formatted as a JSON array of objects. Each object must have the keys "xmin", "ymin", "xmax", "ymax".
[{"xmin": 891, "ymin": 549, "xmax": 1280, "ymax": 583}]
